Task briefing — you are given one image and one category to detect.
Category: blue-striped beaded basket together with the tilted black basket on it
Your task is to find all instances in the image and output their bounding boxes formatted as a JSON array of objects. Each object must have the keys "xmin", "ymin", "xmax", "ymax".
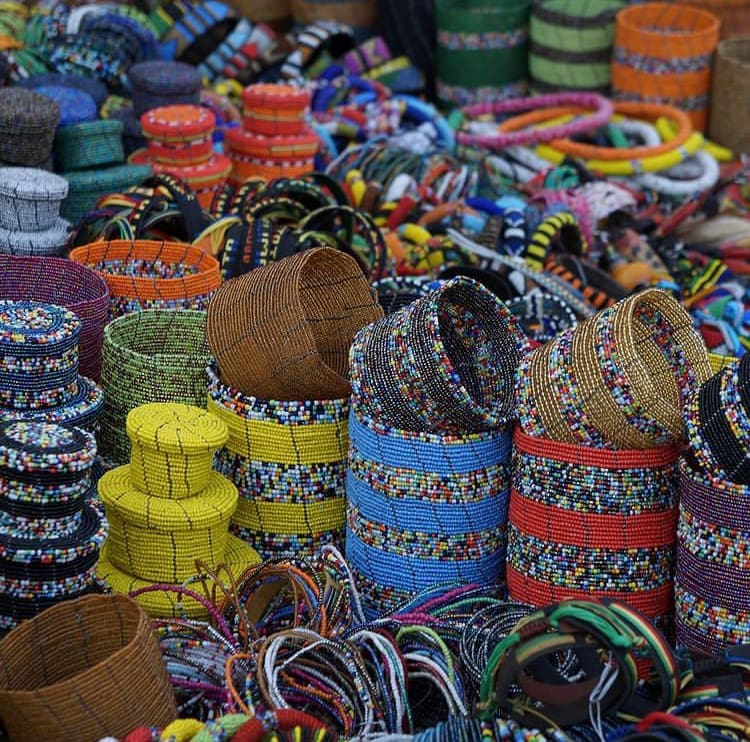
[{"xmin": 346, "ymin": 277, "xmax": 527, "ymax": 617}]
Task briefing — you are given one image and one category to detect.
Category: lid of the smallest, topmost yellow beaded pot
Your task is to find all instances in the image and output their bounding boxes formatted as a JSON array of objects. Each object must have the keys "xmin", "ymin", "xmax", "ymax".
[{"xmin": 126, "ymin": 402, "xmax": 229, "ymax": 455}]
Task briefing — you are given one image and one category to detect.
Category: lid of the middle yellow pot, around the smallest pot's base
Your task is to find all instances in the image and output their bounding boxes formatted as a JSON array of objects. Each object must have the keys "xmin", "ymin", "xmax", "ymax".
[{"xmin": 99, "ymin": 464, "xmax": 239, "ymax": 534}]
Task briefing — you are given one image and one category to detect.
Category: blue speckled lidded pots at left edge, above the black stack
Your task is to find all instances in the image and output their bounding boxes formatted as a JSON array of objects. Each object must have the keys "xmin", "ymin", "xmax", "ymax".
[{"xmin": 0, "ymin": 301, "xmax": 104, "ymax": 430}]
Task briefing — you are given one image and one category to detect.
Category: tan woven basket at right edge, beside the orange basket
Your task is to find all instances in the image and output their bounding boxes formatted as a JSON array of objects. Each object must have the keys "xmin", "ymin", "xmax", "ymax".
[{"xmin": 708, "ymin": 38, "xmax": 750, "ymax": 155}]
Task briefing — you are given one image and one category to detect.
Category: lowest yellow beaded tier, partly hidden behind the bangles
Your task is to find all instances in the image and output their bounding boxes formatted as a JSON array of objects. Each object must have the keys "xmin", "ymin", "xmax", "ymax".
[{"xmin": 96, "ymin": 536, "xmax": 261, "ymax": 620}]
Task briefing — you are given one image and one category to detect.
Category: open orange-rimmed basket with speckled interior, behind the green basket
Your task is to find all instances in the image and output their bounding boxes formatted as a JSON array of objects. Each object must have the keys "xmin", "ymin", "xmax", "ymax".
[{"xmin": 70, "ymin": 240, "xmax": 221, "ymax": 317}]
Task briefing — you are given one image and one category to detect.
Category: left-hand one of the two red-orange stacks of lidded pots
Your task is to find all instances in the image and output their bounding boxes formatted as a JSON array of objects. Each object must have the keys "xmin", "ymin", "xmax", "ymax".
[{"xmin": 130, "ymin": 105, "xmax": 232, "ymax": 208}]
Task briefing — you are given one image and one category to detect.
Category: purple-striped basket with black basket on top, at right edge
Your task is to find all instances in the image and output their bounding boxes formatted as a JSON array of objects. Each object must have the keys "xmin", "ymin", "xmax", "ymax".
[{"xmin": 675, "ymin": 355, "xmax": 750, "ymax": 653}]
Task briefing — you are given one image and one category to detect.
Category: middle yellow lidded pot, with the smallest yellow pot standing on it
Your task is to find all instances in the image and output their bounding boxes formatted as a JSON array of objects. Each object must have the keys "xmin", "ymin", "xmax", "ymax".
[{"xmin": 99, "ymin": 465, "xmax": 238, "ymax": 583}]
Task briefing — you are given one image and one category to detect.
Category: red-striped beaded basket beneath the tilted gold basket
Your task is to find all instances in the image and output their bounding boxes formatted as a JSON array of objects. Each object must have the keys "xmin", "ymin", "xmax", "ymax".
[{"xmin": 507, "ymin": 430, "xmax": 680, "ymax": 626}]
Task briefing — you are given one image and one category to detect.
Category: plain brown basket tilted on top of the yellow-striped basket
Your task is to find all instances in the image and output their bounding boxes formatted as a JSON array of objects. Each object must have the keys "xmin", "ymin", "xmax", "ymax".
[{"xmin": 206, "ymin": 248, "xmax": 383, "ymax": 400}]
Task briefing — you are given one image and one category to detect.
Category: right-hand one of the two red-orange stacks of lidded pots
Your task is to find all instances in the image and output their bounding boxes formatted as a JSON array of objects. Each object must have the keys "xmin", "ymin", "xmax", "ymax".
[{"xmin": 225, "ymin": 83, "xmax": 318, "ymax": 183}]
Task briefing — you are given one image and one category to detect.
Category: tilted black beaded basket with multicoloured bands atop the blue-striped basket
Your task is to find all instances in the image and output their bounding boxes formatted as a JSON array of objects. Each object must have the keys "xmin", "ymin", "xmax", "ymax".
[{"xmin": 351, "ymin": 277, "xmax": 528, "ymax": 433}]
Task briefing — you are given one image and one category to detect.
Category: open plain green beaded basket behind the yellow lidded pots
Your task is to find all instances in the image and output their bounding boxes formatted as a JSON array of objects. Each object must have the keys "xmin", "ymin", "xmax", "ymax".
[{"xmin": 99, "ymin": 309, "xmax": 210, "ymax": 465}]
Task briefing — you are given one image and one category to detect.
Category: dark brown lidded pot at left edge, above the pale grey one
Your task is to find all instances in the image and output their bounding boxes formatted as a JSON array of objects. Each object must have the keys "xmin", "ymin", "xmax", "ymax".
[{"xmin": 0, "ymin": 88, "xmax": 60, "ymax": 169}]
